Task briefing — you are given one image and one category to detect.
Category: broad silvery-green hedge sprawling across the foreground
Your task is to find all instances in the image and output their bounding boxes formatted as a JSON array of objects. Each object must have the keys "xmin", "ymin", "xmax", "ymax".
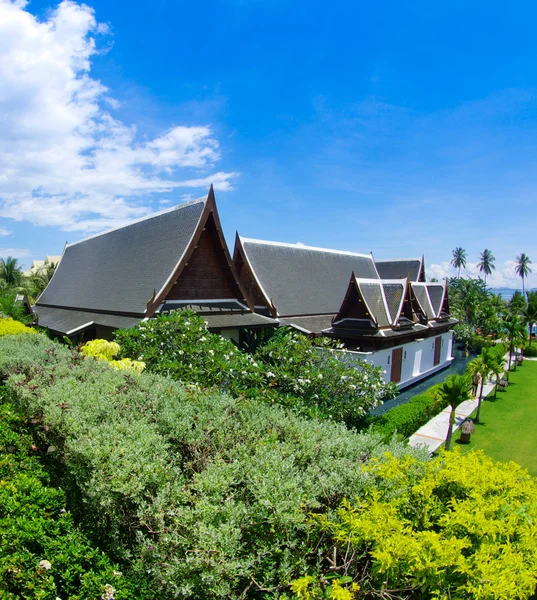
[{"xmin": 0, "ymin": 335, "xmax": 423, "ymax": 600}]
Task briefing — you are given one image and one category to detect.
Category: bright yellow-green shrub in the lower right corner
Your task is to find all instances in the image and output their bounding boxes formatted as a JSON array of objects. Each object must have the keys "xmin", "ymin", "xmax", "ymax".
[{"xmin": 293, "ymin": 452, "xmax": 537, "ymax": 600}]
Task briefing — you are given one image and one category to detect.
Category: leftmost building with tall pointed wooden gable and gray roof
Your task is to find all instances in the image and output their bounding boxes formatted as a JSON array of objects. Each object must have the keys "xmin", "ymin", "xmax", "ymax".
[{"xmin": 34, "ymin": 186, "xmax": 278, "ymax": 340}]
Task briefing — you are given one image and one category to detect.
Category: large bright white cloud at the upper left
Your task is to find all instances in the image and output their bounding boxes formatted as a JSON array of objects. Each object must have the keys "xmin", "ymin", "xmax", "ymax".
[{"xmin": 0, "ymin": 0, "xmax": 237, "ymax": 231}]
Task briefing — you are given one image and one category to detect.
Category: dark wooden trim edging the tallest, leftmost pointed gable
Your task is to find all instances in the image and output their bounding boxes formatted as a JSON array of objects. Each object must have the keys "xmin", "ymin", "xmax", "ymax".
[{"xmin": 146, "ymin": 184, "xmax": 248, "ymax": 317}]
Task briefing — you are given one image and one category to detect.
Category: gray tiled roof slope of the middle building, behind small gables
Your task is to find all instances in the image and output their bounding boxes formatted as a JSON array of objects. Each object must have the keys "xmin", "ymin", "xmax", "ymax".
[{"xmin": 237, "ymin": 238, "xmax": 378, "ymax": 316}]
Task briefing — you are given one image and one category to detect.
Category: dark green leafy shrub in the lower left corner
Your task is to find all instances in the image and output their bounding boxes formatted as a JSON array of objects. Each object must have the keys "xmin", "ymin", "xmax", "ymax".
[{"xmin": 0, "ymin": 388, "xmax": 151, "ymax": 600}]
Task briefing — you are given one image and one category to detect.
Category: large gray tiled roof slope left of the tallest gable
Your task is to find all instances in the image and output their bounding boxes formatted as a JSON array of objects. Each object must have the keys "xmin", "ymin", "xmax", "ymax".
[{"xmin": 37, "ymin": 197, "xmax": 207, "ymax": 316}]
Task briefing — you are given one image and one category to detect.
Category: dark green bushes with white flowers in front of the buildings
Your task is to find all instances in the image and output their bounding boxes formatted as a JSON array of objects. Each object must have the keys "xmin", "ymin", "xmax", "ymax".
[{"xmin": 116, "ymin": 311, "xmax": 395, "ymax": 424}]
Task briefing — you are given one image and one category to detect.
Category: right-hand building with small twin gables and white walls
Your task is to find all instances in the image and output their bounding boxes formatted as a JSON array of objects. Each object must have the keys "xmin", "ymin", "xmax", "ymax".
[{"xmin": 233, "ymin": 235, "xmax": 457, "ymax": 387}]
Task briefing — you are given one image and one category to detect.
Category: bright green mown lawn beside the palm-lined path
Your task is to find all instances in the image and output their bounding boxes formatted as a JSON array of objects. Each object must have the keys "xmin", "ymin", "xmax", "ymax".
[{"xmin": 455, "ymin": 360, "xmax": 537, "ymax": 477}]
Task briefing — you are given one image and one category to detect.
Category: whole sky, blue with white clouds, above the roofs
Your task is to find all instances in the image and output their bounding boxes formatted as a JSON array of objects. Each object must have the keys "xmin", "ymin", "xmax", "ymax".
[{"xmin": 0, "ymin": 0, "xmax": 537, "ymax": 286}]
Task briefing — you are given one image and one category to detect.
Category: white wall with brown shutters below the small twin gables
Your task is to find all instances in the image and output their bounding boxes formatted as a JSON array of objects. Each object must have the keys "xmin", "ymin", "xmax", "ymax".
[{"xmin": 344, "ymin": 331, "xmax": 453, "ymax": 388}]
